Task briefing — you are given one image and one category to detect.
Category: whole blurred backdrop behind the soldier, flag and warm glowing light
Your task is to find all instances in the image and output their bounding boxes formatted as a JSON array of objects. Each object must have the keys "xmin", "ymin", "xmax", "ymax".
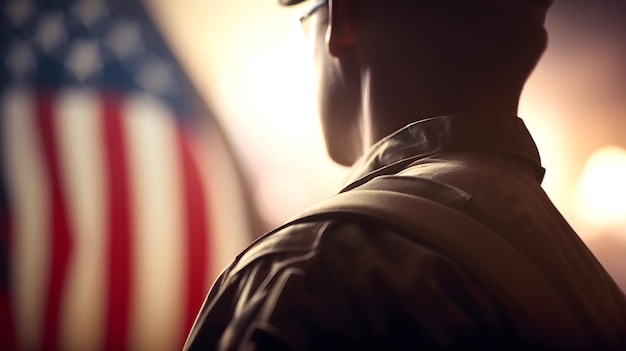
[{"xmin": 0, "ymin": 0, "xmax": 626, "ymax": 350}]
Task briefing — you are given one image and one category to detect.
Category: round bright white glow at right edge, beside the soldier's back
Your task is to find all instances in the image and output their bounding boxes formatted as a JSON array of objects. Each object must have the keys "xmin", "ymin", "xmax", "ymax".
[{"xmin": 576, "ymin": 146, "xmax": 626, "ymax": 226}]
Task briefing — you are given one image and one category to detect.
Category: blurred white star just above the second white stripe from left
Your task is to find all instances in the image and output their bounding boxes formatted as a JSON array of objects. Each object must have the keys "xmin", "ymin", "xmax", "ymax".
[{"xmin": 65, "ymin": 40, "xmax": 102, "ymax": 81}]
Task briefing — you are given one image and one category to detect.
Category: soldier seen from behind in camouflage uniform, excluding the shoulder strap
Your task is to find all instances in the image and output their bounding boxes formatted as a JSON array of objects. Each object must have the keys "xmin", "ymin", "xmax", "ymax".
[{"xmin": 186, "ymin": 0, "xmax": 626, "ymax": 350}]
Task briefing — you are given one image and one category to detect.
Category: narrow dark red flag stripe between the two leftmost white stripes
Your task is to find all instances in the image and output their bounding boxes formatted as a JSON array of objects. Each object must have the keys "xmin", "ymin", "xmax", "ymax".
[{"xmin": 36, "ymin": 93, "xmax": 72, "ymax": 350}]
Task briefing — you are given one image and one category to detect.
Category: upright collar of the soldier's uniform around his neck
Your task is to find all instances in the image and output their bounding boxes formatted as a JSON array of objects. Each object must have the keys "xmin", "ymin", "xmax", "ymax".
[{"xmin": 348, "ymin": 114, "xmax": 545, "ymax": 188}]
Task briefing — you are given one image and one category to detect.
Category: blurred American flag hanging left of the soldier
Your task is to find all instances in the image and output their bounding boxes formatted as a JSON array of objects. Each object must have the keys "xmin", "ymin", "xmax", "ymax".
[{"xmin": 0, "ymin": 0, "xmax": 258, "ymax": 350}]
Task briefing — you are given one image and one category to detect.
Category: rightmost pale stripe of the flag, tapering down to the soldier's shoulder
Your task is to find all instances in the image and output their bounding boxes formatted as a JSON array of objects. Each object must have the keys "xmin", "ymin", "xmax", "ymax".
[{"xmin": 200, "ymin": 122, "xmax": 249, "ymax": 288}]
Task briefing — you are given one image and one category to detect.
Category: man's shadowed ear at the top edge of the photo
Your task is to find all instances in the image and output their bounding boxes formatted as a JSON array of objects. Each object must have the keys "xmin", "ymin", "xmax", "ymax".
[{"xmin": 326, "ymin": 0, "xmax": 359, "ymax": 57}]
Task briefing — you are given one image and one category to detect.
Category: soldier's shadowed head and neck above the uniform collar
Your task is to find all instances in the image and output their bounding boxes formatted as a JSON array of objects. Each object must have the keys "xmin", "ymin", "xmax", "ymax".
[{"xmin": 281, "ymin": 0, "xmax": 550, "ymax": 165}]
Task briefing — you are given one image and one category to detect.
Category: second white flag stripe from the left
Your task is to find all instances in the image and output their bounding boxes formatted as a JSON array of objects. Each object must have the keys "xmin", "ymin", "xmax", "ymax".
[{"xmin": 55, "ymin": 91, "xmax": 107, "ymax": 350}]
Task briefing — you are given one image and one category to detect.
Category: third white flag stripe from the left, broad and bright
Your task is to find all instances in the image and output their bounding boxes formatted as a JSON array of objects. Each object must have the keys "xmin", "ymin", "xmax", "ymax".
[{"xmin": 123, "ymin": 96, "xmax": 186, "ymax": 350}]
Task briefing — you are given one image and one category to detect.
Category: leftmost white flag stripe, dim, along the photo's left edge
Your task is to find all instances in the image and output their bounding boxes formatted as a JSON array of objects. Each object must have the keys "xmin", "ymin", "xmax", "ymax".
[{"xmin": 1, "ymin": 91, "xmax": 51, "ymax": 350}]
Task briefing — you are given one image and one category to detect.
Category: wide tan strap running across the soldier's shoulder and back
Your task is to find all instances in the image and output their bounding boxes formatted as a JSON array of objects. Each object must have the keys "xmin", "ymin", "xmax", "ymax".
[{"xmin": 291, "ymin": 189, "xmax": 591, "ymax": 349}]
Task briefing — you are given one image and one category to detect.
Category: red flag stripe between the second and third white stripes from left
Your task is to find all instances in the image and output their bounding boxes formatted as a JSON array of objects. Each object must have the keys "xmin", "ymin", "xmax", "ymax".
[{"xmin": 102, "ymin": 95, "xmax": 133, "ymax": 351}]
